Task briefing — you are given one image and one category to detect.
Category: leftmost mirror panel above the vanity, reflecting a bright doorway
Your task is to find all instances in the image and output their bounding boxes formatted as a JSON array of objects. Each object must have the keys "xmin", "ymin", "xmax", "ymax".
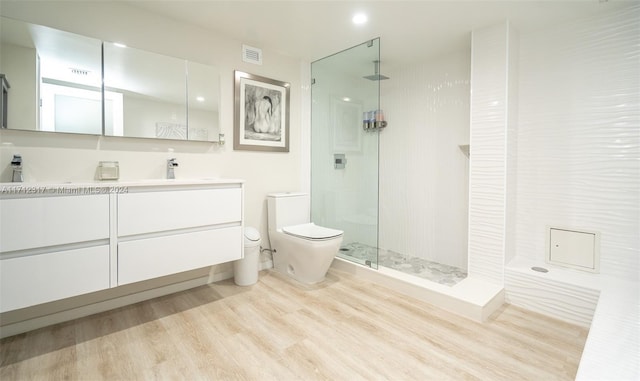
[{"xmin": 0, "ymin": 18, "xmax": 102, "ymax": 135}]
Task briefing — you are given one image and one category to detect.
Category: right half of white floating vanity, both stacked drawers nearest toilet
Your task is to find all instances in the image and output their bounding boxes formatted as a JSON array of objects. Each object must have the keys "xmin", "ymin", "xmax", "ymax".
[{"xmin": 117, "ymin": 184, "xmax": 243, "ymax": 285}]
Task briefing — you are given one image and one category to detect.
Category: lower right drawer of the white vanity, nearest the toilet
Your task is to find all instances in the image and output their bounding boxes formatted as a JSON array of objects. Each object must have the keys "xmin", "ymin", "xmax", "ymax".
[{"xmin": 118, "ymin": 226, "xmax": 243, "ymax": 286}]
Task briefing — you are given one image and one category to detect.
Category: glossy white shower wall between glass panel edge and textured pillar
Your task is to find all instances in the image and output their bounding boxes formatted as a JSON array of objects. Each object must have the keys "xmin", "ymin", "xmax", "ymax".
[{"xmin": 380, "ymin": 49, "xmax": 470, "ymax": 269}]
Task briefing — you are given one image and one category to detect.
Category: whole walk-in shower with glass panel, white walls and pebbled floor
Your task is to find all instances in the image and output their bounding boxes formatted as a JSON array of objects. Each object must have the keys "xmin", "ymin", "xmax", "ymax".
[{"xmin": 311, "ymin": 36, "xmax": 470, "ymax": 285}]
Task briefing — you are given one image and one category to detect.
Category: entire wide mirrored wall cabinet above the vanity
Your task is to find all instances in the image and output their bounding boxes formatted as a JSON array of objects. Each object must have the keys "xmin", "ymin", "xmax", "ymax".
[{"xmin": 0, "ymin": 17, "xmax": 220, "ymax": 141}]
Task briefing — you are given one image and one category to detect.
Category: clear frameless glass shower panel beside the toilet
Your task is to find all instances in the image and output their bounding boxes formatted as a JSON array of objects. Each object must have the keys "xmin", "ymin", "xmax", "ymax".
[{"xmin": 311, "ymin": 39, "xmax": 380, "ymax": 269}]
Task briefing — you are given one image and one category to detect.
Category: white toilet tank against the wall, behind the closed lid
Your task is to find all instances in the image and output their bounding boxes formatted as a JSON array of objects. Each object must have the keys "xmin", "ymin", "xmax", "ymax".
[{"xmin": 267, "ymin": 193, "xmax": 310, "ymax": 230}]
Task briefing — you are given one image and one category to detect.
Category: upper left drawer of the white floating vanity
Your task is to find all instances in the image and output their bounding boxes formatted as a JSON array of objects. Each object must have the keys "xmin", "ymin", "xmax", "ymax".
[{"xmin": 0, "ymin": 194, "xmax": 109, "ymax": 252}]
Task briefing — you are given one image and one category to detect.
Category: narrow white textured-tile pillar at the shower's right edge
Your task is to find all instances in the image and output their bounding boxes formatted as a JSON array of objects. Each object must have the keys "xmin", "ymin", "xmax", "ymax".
[{"xmin": 469, "ymin": 22, "xmax": 518, "ymax": 285}]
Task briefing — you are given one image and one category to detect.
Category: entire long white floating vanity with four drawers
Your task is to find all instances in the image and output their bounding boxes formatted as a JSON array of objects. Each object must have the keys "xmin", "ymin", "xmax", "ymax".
[{"xmin": 0, "ymin": 180, "xmax": 244, "ymax": 312}]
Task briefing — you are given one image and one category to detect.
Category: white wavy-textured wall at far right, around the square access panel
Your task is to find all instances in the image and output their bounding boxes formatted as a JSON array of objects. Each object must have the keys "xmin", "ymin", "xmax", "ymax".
[{"xmin": 516, "ymin": 3, "xmax": 640, "ymax": 281}]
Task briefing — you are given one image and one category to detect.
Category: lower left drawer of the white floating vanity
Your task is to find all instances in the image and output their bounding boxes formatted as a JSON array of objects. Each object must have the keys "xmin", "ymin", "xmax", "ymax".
[{"xmin": 0, "ymin": 245, "xmax": 109, "ymax": 312}]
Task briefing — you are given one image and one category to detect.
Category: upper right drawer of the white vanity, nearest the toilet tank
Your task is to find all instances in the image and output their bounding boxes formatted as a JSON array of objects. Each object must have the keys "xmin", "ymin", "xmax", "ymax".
[{"xmin": 118, "ymin": 188, "xmax": 242, "ymax": 237}]
